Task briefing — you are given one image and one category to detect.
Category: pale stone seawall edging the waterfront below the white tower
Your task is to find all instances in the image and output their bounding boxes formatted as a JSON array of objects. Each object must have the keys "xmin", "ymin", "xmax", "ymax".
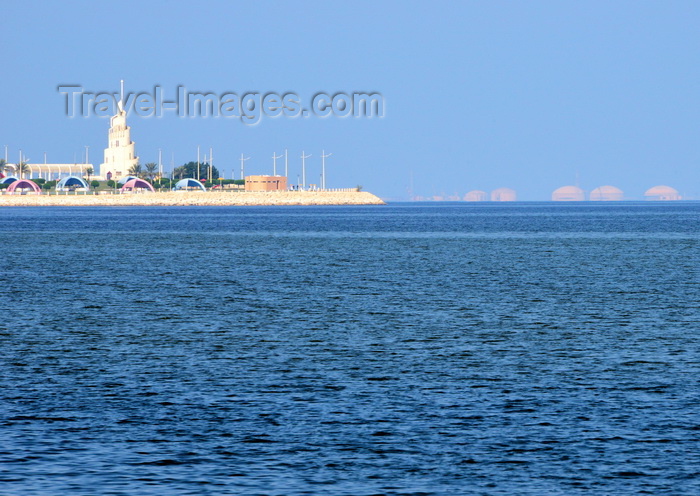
[{"xmin": 0, "ymin": 191, "xmax": 384, "ymax": 207}]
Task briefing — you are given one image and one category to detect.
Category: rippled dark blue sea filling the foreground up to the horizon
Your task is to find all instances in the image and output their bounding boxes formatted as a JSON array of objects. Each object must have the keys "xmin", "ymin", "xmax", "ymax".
[{"xmin": 0, "ymin": 203, "xmax": 700, "ymax": 496}]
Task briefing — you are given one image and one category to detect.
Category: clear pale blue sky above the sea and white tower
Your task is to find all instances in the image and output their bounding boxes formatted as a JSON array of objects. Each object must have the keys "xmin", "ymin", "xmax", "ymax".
[{"xmin": 0, "ymin": 1, "xmax": 700, "ymax": 200}]
